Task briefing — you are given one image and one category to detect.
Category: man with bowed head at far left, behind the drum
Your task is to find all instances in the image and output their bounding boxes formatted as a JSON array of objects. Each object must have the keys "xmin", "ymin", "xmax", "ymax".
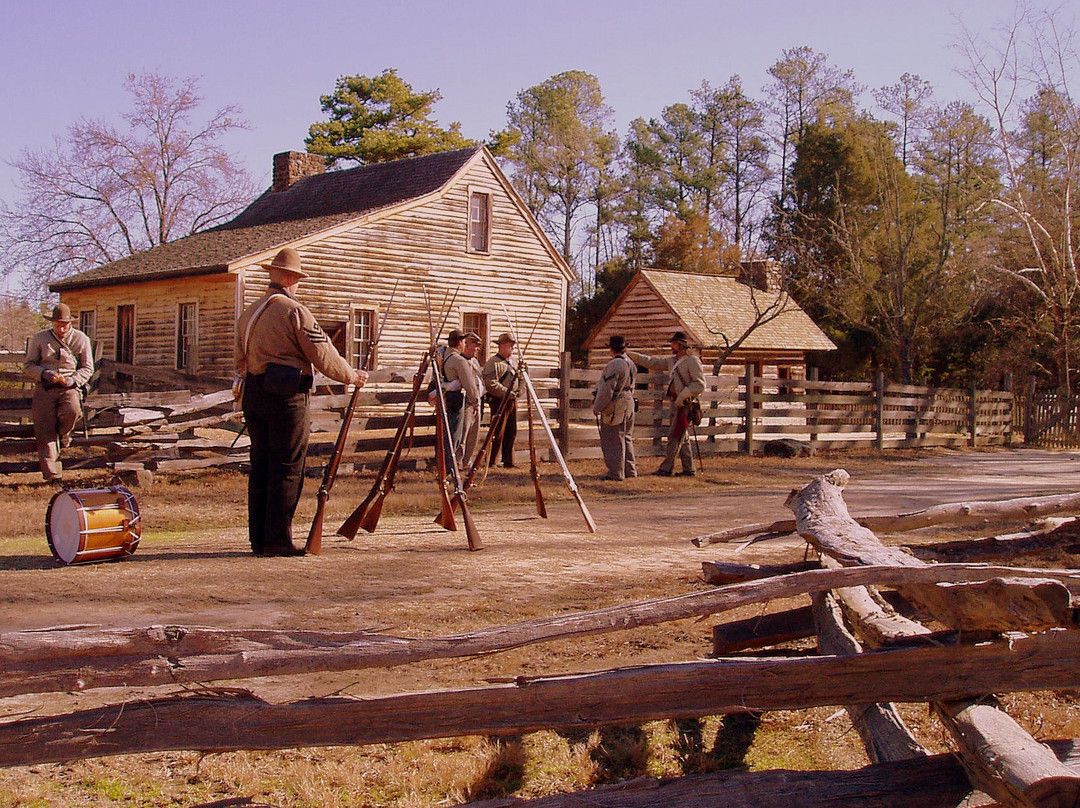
[{"xmin": 23, "ymin": 304, "xmax": 94, "ymax": 482}]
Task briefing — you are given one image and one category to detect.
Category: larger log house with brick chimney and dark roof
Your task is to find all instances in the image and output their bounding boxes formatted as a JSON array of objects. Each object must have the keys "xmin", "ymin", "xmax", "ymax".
[{"xmin": 50, "ymin": 146, "xmax": 571, "ymax": 383}]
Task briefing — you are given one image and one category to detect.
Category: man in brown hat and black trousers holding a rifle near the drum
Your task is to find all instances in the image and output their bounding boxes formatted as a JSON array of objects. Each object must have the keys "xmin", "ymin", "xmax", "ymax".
[{"xmin": 234, "ymin": 247, "xmax": 367, "ymax": 555}]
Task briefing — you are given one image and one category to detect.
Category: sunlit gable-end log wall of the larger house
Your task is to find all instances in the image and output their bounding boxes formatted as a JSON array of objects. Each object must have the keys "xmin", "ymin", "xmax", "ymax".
[{"xmin": 230, "ymin": 154, "xmax": 568, "ymax": 368}]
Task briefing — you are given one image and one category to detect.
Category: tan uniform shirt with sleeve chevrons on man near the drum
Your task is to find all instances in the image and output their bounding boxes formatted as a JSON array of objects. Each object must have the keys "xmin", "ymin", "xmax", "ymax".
[{"xmin": 233, "ymin": 286, "xmax": 353, "ymax": 385}]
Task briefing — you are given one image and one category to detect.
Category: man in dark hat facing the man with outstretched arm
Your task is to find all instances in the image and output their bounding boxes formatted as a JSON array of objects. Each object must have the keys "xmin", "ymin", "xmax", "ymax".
[{"xmin": 593, "ymin": 335, "xmax": 637, "ymax": 480}]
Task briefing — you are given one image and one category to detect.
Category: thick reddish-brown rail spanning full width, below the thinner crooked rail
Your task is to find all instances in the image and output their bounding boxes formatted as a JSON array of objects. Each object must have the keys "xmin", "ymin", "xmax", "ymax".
[{"xmin": 0, "ymin": 631, "xmax": 1080, "ymax": 766}]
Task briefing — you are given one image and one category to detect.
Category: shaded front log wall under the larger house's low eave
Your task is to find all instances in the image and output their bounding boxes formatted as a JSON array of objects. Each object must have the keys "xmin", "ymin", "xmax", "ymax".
[{"xmin": 62, "ymin": 273, "xmax": 237, "ymax": 379}]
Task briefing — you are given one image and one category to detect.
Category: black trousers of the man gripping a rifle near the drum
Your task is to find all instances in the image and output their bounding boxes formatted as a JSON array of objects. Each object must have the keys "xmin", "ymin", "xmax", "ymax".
[{"xmin": 243, "ymin": 375, "xmax": 311, "ymax": 553}]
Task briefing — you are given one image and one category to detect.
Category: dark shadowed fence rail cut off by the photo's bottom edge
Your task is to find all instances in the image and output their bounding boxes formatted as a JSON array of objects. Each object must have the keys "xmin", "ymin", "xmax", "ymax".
[{"xmin": 459, "ymin": 741, "xmax": 1080, "ymax": 808}]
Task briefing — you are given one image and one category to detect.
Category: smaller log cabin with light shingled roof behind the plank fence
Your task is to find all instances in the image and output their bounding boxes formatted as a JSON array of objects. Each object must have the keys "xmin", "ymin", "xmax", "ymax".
[{"xmin": 584, "ymin": 261, "xmax": 836, "ymax": 378}]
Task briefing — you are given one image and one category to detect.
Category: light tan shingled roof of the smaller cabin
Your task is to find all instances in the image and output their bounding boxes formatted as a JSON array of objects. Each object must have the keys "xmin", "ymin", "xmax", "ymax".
[{"xmin": 642, "ymin": 269, "xmax": 836, "ymax": 351}]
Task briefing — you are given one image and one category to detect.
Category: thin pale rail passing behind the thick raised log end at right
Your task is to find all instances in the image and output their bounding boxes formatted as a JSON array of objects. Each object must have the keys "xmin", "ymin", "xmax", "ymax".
[{"xmin": 690, "ymin": 491, "xmax": 1080, "ymax": 547}]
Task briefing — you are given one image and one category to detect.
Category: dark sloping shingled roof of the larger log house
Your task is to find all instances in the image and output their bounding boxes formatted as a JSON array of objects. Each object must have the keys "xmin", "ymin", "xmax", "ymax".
[{"xmin": 49, "ymin": 146, "xmax": 482, "ymax": 292}]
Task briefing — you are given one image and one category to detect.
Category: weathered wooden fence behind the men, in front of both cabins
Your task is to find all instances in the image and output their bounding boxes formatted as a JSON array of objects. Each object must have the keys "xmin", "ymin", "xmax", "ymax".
[{"xmin": 0, "ymin": 356, "xmax": 1015, "ymax": 473}]
